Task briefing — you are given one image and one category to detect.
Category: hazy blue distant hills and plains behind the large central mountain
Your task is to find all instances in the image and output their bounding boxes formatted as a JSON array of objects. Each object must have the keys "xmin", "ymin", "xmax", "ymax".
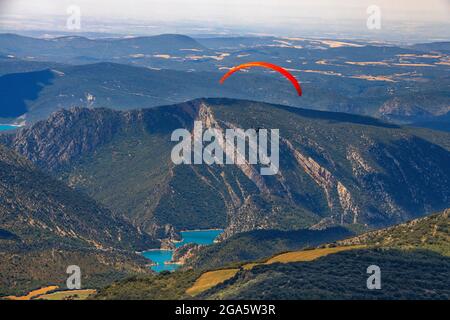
[{"xmin": 0, "ymin": 34, "xmax": 450, "ymax": 127}]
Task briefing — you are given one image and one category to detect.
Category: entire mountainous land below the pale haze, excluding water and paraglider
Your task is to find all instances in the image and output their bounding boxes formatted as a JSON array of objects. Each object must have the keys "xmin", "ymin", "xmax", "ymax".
[{"xmin": 0, "ymin": 34, "xmax": 450, "ymax": 300}]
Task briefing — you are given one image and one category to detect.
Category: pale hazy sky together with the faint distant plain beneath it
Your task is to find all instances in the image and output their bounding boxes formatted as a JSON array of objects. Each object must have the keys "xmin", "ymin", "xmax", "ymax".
[{"xmin": 0, "ymin": 0, "xmax": 450, "ymax": 41}]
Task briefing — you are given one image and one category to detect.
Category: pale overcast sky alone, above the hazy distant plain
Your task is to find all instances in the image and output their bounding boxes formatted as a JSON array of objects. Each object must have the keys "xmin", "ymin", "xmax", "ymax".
[{"xmin": 0, "ymin": 0, "xmax": 450, "ymax": 39}]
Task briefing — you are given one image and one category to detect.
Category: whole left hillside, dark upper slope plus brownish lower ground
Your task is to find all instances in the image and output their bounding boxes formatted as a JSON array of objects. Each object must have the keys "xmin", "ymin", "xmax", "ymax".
[{"xmin": 0, "ymin": 145, "xmax": 159, "ymax": 296}]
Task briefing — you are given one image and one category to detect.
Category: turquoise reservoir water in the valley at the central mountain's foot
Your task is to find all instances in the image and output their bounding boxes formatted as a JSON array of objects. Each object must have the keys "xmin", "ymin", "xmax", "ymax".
[{"xmin": 142, "ymin": 230, "xmax": 223, "ymax": 272}]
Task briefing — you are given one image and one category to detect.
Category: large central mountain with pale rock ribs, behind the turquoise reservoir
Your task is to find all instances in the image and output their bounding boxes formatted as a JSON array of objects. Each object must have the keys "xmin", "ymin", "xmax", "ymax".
[{"xmin": 9, "ymin": 99, "xmax": 450, "ymax": 237}]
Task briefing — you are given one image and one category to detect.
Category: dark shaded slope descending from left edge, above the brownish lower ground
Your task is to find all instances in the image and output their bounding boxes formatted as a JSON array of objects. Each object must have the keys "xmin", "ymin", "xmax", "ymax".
[{"xmin": 0, "ymin": 145, "xmax": 157, "ymax": 251}]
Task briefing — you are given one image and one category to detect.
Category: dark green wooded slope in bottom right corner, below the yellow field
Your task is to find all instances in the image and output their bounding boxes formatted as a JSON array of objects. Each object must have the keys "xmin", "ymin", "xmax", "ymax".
[{"xmin": 199, "ymin": 249, "xmax": 450, "ymax": 300}]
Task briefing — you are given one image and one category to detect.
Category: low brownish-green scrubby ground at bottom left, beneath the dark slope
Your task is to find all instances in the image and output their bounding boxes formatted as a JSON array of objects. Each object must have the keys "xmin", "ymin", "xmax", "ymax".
[{"xmin": 0, "ymin": 248, "xmax": 150, "ymax": 299}]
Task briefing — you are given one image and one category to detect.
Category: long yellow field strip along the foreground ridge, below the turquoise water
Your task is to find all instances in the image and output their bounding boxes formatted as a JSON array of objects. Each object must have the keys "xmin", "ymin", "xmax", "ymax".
[{"xmin": 186, "ymin": 245, "xmax": 365, "ymax": 296}]
